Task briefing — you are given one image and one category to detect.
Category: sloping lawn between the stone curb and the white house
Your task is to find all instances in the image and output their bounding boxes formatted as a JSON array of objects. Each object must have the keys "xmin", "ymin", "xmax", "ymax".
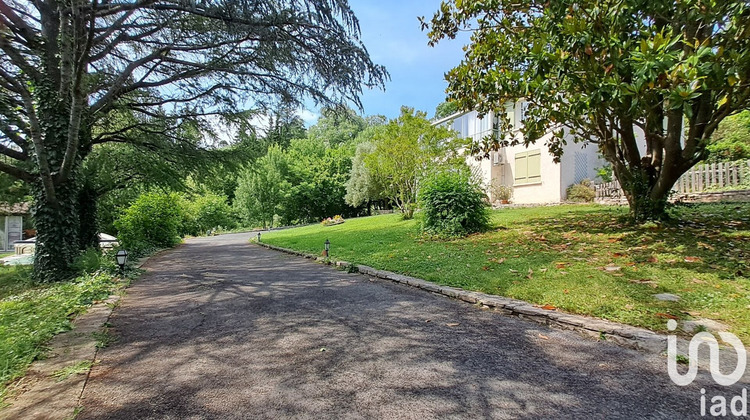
[{"xmin": 262, "ymin": 204, "xmax": 750, "ymax": 343}]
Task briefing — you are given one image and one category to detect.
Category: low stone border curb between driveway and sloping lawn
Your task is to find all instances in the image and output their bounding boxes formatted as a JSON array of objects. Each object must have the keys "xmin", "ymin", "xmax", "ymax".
[{"xmin": 252, "ymin": 242, "xmax": 667, "ymax": 353}]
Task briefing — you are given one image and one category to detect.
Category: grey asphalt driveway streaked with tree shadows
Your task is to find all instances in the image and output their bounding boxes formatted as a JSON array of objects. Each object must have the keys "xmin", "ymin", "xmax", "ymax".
[{"xmin": 78, "ymin": 234, "xmax": 747, "ymax": 419}]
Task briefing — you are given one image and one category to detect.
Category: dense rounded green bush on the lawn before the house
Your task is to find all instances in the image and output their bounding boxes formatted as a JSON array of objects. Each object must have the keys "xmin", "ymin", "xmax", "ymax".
[{"xmin": 419, "ymin": 171, "xmax": 490, "ymax": 236}]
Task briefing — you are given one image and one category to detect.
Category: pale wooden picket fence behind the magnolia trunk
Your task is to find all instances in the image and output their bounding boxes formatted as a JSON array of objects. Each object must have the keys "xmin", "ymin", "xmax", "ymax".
[{"xmin": 594, "ymin": 160, "xmax": 750, "ymax": 200}]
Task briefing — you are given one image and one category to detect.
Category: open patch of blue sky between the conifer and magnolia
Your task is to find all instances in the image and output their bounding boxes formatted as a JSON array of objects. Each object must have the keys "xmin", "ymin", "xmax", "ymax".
[{"xmin": 303, "ymin": 0, "xmax": 468, "ymax": 123}]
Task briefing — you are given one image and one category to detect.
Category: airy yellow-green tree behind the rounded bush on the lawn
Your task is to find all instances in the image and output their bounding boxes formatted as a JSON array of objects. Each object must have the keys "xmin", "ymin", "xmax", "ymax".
[{"xmin": 364, "ymin": 107, "xmax": 460, "ymax": 219}]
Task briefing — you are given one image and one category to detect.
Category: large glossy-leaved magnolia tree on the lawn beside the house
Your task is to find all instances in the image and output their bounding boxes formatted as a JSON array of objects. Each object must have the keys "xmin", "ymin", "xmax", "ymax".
[{"xmin": 421, "ymin": 0, "xmax": 750, "ymax": 220}]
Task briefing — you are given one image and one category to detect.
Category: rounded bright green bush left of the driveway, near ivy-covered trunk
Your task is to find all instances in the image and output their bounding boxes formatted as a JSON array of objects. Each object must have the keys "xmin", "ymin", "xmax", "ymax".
[{"xmin": 115, "ymin": 193, "xmax": 184, "ymax": 255}]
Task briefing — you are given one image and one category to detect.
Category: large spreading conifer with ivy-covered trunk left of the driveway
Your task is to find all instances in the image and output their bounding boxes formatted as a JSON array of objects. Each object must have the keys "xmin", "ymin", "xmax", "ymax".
[{"xmin": 0, "ymin": 0, "xmax": 388, "ymax": 281}]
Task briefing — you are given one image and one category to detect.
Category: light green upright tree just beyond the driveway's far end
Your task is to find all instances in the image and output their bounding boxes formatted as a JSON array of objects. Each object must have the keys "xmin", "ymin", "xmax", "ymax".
[{"xmin": 234, "ymin": 145, "xmax": 289, "ymax": 228}]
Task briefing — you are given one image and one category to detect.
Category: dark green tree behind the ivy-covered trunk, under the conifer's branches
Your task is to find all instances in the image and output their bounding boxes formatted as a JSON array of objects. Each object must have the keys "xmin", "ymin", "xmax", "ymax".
[{"xmin": 78, "ymin": 111, "xmax": 225, "ymax": 249}]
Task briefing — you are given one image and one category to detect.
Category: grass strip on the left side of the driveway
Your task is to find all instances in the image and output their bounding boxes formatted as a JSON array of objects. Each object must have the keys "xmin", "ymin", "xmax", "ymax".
[{"xmin": 0, "ymin": 266, "xmax": 116, "ymax": 406}]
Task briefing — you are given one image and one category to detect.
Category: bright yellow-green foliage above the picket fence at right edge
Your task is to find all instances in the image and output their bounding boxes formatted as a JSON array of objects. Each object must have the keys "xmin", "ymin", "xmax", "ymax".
[{"xmin": 708, "ymin": 111, "xmax": 750, "ymax": 162}]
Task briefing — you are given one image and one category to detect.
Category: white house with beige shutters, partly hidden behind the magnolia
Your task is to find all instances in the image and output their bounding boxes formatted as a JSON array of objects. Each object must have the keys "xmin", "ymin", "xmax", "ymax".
[{"xmin": 433, "ymin": 102, "xmax": 605, "ymax": 204}]
